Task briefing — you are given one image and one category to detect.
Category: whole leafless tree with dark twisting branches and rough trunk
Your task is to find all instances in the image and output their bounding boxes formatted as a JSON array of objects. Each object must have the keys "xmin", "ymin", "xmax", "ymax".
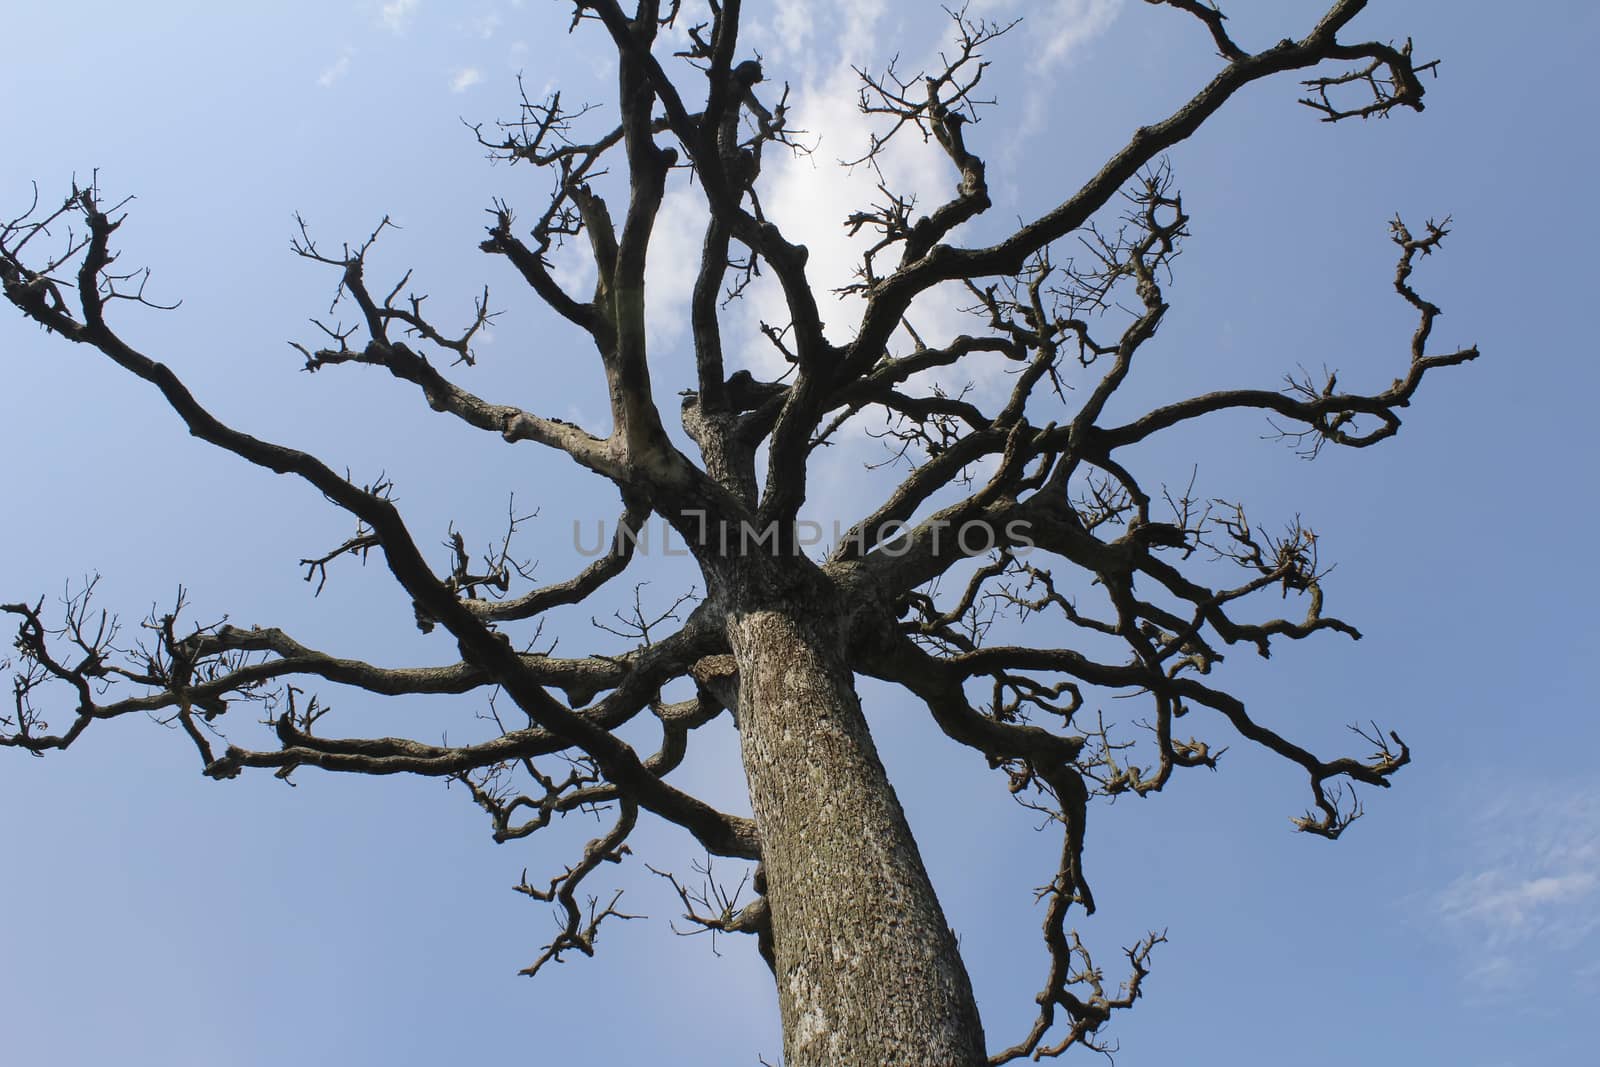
[{"xmin": 0, "ymin": 0, "xmax": 1477, "ymax": 1064}]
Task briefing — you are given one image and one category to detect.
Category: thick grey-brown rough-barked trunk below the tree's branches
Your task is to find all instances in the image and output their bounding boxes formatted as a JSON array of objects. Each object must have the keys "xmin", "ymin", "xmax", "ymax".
[{"xmin": 730, "ymin": 605, "xmax": 987, "ymax": 1067}]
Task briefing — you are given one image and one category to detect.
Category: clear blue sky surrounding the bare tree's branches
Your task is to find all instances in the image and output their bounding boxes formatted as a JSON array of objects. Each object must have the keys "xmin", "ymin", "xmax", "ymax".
[{"xmin": 0, "ymin": 0, "xmax": 1600, "ymax": 1067}]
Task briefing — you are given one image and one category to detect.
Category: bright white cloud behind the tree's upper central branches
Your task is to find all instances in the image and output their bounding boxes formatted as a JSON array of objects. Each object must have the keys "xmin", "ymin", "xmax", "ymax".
[{"xmin": 651, "ymin": 0, "xmax": 1122, "ymax": 462}]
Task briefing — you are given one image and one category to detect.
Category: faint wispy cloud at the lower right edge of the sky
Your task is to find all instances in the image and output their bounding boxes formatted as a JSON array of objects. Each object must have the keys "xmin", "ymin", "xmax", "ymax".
[{"xmin": 1432, "ymin": 784, "xmax": 1600, "ymax": 989}]
